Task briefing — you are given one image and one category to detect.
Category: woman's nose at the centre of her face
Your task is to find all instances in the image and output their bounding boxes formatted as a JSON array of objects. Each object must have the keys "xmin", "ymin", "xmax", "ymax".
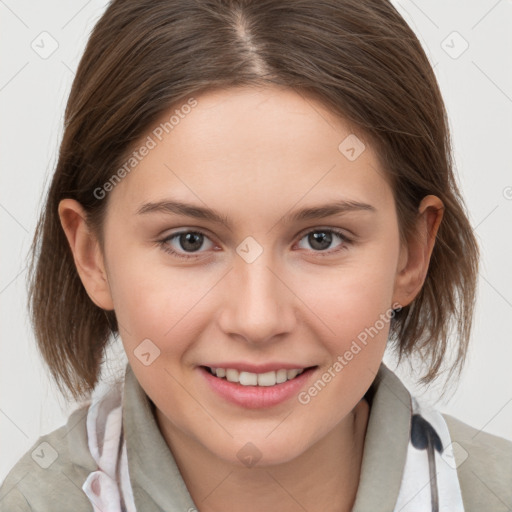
[{"xmin": 219, "ymin": 251, "xmax": 297, "ymax": 344}]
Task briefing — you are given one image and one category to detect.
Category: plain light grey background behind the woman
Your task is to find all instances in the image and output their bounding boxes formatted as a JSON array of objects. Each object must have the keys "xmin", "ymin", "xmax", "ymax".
[{"xmin": 0, "ymin": 0, "xmax": 512, "ymax": 480}]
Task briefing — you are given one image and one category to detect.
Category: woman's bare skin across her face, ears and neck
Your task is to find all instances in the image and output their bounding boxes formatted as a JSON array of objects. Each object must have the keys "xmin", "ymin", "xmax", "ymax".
[{"xmin": 59, "ymin": 87, "xmax": 443, "ymax": 512}]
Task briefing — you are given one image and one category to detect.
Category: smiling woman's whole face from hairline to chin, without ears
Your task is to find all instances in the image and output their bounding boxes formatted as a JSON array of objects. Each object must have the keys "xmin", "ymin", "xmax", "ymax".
[{"xmin": 90, "ymin": 88, "xmax": 403, "ymax": 464}]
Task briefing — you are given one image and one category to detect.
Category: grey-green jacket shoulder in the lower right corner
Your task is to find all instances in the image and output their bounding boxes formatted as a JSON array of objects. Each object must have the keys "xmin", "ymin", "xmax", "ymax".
[{"xmin": 443, "ymin": 414, "xmax": 512, "ymax": 511}]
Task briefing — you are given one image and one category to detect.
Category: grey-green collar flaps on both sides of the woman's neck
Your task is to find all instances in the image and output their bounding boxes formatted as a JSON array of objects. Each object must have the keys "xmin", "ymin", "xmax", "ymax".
[{"xmin": 123, "ymin": 363, "xmax": 412, "ymax": 512}]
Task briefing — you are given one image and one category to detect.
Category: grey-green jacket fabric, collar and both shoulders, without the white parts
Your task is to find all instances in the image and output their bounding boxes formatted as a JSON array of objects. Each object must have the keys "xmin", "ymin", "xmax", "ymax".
[{"xmin": 0, "ymin": 363, "xmax": 512, "ymax": 512}]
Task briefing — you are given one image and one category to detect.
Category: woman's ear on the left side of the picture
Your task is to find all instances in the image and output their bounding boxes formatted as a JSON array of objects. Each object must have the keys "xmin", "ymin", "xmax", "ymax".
[{"xmin": 59, "ymin": 199, "xmax": 114, "ymax": 310}]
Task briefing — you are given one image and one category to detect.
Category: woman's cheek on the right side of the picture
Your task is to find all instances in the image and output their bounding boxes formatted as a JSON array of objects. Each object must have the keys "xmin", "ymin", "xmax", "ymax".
[{"xmin": 306, "ymin": 248, "xmax": 397, "ymax": 388}]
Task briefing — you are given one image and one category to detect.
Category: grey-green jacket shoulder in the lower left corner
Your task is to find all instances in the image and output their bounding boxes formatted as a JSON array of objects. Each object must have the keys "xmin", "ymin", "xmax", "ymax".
[{"xmin": 0, "ymin": 405, "xmax": 96, "ymax": 512}]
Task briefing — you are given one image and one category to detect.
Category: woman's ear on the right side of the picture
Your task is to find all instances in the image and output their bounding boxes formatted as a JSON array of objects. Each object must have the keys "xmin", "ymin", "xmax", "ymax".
[{"xmin": 393, "ymin": 195, "xmax": 444, "ymax": 306}]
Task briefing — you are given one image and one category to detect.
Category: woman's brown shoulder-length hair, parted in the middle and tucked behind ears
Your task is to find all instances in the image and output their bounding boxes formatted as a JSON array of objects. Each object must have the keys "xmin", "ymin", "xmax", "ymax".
[{"xmin": 29, "ymin": 0, "xmax": 478, "ymax": 399}]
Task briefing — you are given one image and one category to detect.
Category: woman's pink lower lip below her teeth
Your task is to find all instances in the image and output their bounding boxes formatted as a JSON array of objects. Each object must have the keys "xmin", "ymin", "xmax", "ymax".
[{"xmin": 199, "ymin": 366, "xmax": 315, "ymax": 409}]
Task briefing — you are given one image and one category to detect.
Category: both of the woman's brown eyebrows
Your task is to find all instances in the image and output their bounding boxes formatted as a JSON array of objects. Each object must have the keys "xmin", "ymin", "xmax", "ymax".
[{"xmin": 137, "ymin": 200, "xmax": 377, "ymax": 228}]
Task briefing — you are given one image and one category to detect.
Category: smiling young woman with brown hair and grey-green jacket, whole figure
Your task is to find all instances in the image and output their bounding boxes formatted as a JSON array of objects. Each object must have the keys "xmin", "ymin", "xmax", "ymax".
[{"xmin": 0, "ymin": 0, "xmax": 512, "ymax": 512}]
